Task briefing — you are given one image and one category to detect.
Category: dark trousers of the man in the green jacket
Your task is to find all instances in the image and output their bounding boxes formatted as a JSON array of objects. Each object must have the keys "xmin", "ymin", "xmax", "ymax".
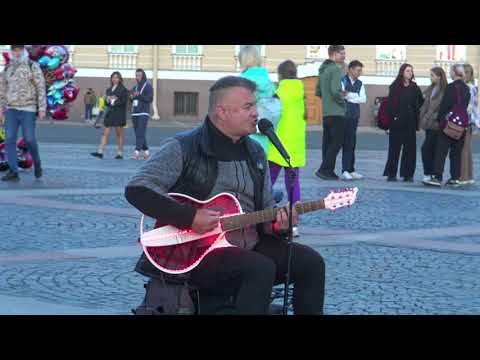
[{"xmin": 320, "ymin": 116, "xmax": 345, "ymax": 174}]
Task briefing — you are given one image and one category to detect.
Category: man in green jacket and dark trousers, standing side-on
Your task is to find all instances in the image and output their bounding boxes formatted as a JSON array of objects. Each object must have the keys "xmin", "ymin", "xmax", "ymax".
[{"xmin": 315, "ymin": 45, "xmax": 347, "ymax": 180}]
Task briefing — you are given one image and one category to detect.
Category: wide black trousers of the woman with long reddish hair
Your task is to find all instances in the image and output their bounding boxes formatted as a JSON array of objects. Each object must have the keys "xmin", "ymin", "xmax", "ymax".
[{"xmin": 383, "ymin": 128, "xmax": 417, "ymax": 177}]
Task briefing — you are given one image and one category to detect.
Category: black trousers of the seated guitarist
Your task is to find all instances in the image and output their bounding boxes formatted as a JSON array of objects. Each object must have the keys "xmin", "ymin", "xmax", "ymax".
[{"xmin": 190, "ymin": 236, "xmax": 325, "ymax": 314}]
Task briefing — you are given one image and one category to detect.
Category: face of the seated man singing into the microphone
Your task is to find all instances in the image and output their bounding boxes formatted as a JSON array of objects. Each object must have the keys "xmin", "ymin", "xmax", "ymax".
[{"xmin": 217, "ymin": 87, "xmax": 258, "ymax": 137}]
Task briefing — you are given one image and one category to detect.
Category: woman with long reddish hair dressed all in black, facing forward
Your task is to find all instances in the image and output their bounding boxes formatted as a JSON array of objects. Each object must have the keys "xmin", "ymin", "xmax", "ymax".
[{"xmin": 383, "ymin": 64, "xmax": 424, "ymax": 182}]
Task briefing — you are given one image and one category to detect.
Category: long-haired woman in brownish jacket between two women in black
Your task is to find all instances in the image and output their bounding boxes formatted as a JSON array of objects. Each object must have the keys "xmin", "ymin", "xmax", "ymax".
[{"xmin": 419, "ymin": 67, "xmax": 448, "ymax": 181}]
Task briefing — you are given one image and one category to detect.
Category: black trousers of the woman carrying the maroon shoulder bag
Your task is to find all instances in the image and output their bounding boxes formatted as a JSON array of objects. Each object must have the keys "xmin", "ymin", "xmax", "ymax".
[{"xmin": 434, "ymin": 131, "xmax": 465, "ymax": 180}]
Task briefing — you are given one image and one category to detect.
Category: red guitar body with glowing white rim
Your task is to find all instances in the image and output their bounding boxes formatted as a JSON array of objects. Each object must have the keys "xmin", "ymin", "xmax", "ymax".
[{"xmin": 142, "ymin": 193, "xmax": 243, "ymax": 274}]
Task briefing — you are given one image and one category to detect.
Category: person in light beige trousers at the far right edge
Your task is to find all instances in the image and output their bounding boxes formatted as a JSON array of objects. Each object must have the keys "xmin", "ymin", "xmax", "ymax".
[{"xmin": 460, "ymin": 64, "xmax": 480, "ymax": 185}]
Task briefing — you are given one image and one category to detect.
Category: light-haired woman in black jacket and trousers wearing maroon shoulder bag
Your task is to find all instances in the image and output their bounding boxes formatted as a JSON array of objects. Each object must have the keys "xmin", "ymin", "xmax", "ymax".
[{"xmin": 424, "ymin": 64, "xmax": 470, "ymax": 187}]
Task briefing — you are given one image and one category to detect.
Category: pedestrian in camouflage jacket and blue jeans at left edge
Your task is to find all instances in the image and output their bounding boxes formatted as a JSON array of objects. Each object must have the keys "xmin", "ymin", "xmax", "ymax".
[{"xmin": 0, "ymin": 45, "xmax": 47, "ymax": 181}]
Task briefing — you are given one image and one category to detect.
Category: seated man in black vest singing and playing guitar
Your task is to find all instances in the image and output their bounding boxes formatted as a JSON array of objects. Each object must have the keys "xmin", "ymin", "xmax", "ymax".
[{"xmin": 125, "ymin": 76, "xmax": 325, "ymax": 314}]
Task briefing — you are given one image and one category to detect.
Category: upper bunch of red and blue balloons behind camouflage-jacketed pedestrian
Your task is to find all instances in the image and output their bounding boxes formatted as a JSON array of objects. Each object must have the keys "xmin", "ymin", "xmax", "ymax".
[{"xmin": 3, "ymin": 45, "xmax": 78, "ymax": 120}]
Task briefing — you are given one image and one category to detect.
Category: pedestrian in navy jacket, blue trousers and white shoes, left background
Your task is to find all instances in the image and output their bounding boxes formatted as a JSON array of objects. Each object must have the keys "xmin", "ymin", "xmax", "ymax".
[{"xmin": 130, "ymin": 69, "xmax": 153, "ymax": 160}]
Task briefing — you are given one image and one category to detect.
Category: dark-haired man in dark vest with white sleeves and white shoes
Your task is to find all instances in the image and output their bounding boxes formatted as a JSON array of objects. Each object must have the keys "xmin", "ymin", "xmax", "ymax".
[{"xmin": 341, "ymin": 60, "xmax": 367, "ymax": 180}]
